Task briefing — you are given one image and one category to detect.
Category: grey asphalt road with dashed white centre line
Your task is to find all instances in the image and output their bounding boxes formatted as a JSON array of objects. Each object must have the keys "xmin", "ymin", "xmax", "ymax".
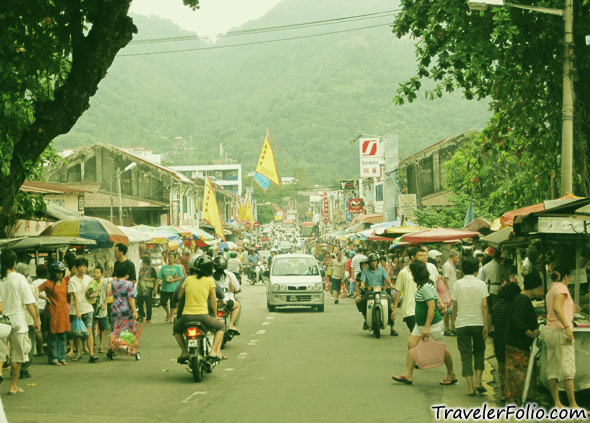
[{"xmin": 1, "ymin": 285, "xmax": 560, "ymax": 423}]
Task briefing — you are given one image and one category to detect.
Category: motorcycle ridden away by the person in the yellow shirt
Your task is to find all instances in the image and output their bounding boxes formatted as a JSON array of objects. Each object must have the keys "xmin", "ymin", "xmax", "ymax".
[{"xmin": 178, "ymin": 322, "xmax": 219, "ymax": 382}]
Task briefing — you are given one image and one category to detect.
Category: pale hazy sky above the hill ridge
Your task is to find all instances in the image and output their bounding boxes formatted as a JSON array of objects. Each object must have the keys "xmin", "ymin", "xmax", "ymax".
[{"xmin": 131, "ymin": 0, "xmax": 281, "ymax": 36}]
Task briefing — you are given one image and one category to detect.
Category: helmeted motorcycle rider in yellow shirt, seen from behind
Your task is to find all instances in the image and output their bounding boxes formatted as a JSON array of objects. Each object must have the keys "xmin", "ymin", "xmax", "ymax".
[{"xmin": 173, "ymin": 254, "xmax": 225, "ymax": 362}]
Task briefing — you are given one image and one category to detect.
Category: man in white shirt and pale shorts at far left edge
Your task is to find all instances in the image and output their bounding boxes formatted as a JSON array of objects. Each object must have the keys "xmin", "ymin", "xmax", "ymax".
[{"xmin": 0, "ymin": 251, "xmax": 41, "ymax": 395}]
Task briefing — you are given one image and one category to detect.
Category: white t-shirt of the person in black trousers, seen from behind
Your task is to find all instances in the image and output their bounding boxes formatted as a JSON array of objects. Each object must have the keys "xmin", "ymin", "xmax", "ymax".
[{"xmin": 451, "ymin": 275, "xmax": 489, "ymax": 328}]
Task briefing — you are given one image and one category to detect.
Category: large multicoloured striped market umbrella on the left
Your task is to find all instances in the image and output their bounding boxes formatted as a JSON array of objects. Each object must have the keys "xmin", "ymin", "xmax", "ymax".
[{"xmin": 39, "ymin": 216, "xmax": 129, "ymax": 248}]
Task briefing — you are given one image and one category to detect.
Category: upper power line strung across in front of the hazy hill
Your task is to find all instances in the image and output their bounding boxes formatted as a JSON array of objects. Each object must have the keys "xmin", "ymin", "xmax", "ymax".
[{"xmin": 130, "ymin": 9, "xmax": 400, "ymax": 45}]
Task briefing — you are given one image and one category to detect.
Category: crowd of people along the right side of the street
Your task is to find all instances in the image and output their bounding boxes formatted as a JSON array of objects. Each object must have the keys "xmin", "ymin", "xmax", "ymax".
[{"xmin": 308, "ymin": 239, "xmax": 577, "ymax": 407}]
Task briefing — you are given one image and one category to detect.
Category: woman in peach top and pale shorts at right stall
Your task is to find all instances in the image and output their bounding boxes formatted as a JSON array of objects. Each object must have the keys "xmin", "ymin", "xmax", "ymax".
[{"xmin": 544, "ymin": 266, "xmax": 578, "ymax": 408}]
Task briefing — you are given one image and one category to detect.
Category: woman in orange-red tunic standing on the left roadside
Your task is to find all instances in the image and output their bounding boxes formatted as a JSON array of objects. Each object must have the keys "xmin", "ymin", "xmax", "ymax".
[{"xmin": 39, "ymin": 261, "xmax": 70, "ymax": 366}]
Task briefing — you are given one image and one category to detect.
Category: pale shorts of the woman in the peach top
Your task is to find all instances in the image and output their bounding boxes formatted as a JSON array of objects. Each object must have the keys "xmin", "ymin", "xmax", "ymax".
[{"xmin": 543, "ymin": 328, "xmax": 576, "ymax": 380}]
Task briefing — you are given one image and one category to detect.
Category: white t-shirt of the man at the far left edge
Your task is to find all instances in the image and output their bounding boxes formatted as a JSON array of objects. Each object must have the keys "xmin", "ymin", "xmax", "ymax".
[{"xmin": 0, "ymin": 272, "xmax": 35, "ymax": 333}]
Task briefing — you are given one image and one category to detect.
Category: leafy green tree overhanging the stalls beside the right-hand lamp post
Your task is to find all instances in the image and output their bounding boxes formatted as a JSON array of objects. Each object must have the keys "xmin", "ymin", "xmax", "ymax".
[{"xmin": 393, "ymin": 0, "xmax": 590, "ymax": 201}]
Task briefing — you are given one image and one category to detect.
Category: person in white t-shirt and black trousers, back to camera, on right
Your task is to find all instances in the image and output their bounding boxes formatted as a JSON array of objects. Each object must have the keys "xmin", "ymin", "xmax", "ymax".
[{"xmin": 451, "ymin": 257, "xmax": 489, "ymax": 396}]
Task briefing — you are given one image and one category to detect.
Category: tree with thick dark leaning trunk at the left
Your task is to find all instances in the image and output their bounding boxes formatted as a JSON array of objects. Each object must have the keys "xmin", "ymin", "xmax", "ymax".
[{"xmin": 0, "ymin": 0, "xmax": 198, "ymax": 236}]
